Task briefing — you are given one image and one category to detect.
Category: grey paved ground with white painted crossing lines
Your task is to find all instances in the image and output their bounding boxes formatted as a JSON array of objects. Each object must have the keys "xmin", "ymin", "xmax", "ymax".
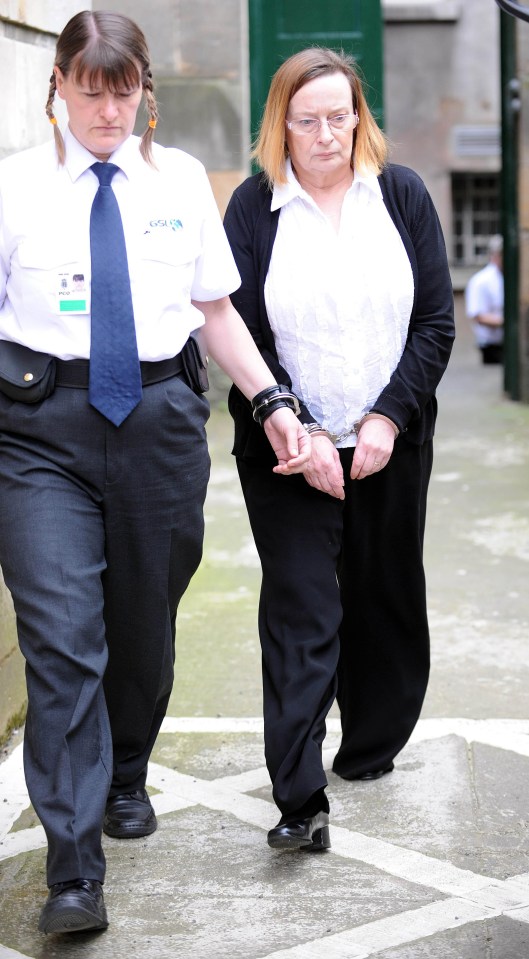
[{"xmin": 0, "ymin": 294, "xmax": 529, "ymax": 959}]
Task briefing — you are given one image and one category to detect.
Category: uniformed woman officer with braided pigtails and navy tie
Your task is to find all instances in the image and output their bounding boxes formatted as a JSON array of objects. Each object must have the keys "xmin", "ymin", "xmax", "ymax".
[{"xmin": 0, "ymin": 11, "xmax": 310, "ymax": 933}]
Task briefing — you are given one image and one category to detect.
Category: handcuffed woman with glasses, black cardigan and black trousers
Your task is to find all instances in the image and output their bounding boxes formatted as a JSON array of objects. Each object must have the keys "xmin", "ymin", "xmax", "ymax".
[{"xmin": 224, "ymin": 48, "xmax": 454, "ymax": 850}]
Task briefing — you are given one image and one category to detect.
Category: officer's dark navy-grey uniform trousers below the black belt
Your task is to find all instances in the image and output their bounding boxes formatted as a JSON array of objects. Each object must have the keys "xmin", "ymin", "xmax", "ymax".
[{"xmin": 0, "ymin": 377, "xmax": 209, "ymax": 885}]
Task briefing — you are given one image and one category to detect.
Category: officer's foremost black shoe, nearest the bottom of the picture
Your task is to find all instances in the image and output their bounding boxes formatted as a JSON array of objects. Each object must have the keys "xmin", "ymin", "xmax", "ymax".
[{"xmin": 39, "ymin": 879, "xmax": 108, "ymax": 932}]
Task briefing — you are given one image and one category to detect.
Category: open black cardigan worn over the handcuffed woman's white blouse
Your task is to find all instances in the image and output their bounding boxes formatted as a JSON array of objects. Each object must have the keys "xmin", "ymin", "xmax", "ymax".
[{"xmin": 224, "ymin": 164, "xmax": 455, "ymax": 460}]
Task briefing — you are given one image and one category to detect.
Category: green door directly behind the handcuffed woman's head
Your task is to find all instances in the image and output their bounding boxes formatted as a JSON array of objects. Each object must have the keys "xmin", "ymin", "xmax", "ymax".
[{"xmin": 248, "ymin": 0, "xmax": 383, "ymax": 139}]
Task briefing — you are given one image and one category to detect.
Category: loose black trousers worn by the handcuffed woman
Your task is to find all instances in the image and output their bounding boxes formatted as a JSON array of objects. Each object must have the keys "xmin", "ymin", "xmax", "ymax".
[{"xmin": 237, "ymin": 438, "xmax": 432, "ymax": 814}]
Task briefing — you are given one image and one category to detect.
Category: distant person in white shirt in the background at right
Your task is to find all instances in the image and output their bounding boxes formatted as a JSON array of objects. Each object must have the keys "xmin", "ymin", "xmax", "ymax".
[{"xmin": 465, "ymin": 234, "xmax": 504, "ymax": 364}]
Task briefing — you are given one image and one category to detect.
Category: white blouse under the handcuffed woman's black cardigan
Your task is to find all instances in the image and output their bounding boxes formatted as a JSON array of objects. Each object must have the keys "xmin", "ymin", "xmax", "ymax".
[{"xmin": 265, "ymin": 161, "xmax": 413, "ymax": 447}]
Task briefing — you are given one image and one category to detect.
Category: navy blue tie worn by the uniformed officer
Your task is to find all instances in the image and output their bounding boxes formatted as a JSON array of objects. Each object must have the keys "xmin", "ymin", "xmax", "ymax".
[{"xmin": 88, "ymin": 163, "xmax": 141, "ymax": 426}]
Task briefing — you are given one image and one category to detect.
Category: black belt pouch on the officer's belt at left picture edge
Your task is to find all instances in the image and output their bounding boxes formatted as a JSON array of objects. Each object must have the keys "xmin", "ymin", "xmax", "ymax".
[{"xmin": 0, "ymin": 340, "xmax": 55, "ymax": 403}]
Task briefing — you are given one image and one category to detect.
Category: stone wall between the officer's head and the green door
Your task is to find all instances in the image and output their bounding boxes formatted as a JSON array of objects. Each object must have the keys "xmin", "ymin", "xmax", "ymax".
[{"xmin": 92, "ymin": 0, "xmax": 249, "ymax": 212}]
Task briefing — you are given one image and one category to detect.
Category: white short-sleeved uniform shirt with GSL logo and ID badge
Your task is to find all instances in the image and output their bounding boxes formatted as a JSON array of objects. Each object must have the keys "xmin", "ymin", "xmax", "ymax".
[{"xmin": 0, "ymin": 130, "xmax": 240, "ymax": 361}]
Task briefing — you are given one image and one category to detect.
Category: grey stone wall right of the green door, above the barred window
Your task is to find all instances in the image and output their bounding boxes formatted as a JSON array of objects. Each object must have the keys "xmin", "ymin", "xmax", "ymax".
[{"xmin": 383, "ymin": 0, "xmax": 501, "ymax": 274}]
